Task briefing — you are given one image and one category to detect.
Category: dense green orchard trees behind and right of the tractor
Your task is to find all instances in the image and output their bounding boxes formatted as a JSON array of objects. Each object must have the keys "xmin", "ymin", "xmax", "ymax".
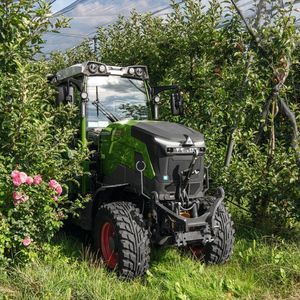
[{"xmin": 92, "ymin": 0, "xmax": 300, "ymax": 228}]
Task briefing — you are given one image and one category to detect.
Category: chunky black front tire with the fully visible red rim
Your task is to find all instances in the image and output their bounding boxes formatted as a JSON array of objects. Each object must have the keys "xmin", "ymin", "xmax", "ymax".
[{"xmin": 93, "ymin": 202, "xmax": 150, "ymax": 279}]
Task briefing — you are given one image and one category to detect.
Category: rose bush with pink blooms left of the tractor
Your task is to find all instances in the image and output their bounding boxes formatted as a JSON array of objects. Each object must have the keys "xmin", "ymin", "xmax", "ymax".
[{"xmin": 0, "ymin": 164, "xmax": 85, "ymax": 264}]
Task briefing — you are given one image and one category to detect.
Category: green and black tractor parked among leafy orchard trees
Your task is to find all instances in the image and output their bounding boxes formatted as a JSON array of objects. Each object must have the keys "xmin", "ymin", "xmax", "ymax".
[{"xmin": 51, "ymin": 61, "xmax": 234, "ymax": 279}]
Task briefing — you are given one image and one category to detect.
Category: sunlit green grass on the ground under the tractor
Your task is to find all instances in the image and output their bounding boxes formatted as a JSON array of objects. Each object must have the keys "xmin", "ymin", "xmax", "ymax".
[{"xmin": 0, "ymin": 216, "xmax": 300, "ymax": 300}]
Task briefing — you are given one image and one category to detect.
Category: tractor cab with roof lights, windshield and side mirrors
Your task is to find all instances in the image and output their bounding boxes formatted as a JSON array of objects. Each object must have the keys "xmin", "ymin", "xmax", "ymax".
[{"xmin": 51, "ymin": 61, "xmax": 182, "ymax": 142}]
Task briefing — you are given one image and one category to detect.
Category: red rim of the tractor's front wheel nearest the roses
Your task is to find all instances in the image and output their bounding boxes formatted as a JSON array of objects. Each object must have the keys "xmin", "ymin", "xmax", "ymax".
[{"xmin": 100, "ymin": 222, "xmax": 118, "ymax": 269}]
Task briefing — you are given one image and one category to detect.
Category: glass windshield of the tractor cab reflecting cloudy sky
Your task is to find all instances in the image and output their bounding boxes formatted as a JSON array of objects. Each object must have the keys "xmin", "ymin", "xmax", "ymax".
[{"xmin": 87, "ymin": 75, "xmax": 148, "ymax": 128}]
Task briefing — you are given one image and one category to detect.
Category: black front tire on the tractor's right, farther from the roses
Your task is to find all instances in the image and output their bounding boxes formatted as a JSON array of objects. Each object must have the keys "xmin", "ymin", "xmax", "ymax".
[{"xmin": 190, "ymin": 197, "xmax": 235, "ymax": 264}]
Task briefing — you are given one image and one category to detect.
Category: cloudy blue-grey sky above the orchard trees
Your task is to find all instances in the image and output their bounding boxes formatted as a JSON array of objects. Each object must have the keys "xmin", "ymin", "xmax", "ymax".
[{"xmin": 43, "ymin": 0, "xmax": 300, "ymax": 54}]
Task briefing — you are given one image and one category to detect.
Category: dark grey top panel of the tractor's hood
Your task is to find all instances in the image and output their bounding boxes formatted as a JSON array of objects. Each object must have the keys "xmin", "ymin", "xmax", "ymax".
[{"xmin": 131, "ymin": 121, "xmax": 205, "ymax": 147}]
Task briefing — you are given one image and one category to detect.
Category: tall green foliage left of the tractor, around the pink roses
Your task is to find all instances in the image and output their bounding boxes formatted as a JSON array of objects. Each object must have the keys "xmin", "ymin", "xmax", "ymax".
[{"xmin": 0, "ymin": 0, "xmax": 88, "ymax": 263}]
